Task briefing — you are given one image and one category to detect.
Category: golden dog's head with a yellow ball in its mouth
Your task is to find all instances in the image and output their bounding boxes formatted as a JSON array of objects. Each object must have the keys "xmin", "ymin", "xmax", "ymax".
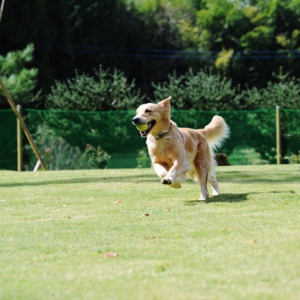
[{"xmin": 132, "ymin": 97, "xmax": 172, "ymax": 137}]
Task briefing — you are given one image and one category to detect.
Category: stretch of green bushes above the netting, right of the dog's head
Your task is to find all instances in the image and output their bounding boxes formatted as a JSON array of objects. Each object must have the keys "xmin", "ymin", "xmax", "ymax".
[{"xmin": 153, "ymin": 69, "xmax": 300, "ymax": 111}]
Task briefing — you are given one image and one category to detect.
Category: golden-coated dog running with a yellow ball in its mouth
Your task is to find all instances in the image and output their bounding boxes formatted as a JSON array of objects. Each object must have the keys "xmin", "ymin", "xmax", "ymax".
[{"xmin": 133, "ymin": 97, "xmax": 229, "ymax": 200}]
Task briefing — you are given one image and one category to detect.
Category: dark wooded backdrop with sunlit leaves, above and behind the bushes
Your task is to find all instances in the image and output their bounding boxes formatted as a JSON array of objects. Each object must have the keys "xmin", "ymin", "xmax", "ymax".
[{"xmin": 0, "ymin": 0, "xmax": 300, "ymax": 105}]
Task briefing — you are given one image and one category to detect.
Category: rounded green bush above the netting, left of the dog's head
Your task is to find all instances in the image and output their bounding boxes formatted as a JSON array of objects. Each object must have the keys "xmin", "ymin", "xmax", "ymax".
[{"xmin": 46, "ymin": 66, "xmax": 144, "ymax": 111}]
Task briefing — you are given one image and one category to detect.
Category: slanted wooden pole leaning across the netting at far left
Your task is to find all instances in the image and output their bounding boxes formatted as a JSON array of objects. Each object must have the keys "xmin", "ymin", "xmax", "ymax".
[{"xmin": 0, "ymin": 77, "xmax": 47, "ymax": 170}]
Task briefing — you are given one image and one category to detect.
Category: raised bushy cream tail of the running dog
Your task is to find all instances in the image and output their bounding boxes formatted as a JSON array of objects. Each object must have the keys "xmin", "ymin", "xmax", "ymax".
[{"xmin": 199, "ymin": 116, "xmax": 230, "ymax": 149}]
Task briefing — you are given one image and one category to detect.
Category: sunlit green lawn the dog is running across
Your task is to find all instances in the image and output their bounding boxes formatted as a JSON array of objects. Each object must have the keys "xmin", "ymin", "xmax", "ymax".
[{"xmin": 0, "ymin": 165, "xmax": 300, "ymax": 300}]
